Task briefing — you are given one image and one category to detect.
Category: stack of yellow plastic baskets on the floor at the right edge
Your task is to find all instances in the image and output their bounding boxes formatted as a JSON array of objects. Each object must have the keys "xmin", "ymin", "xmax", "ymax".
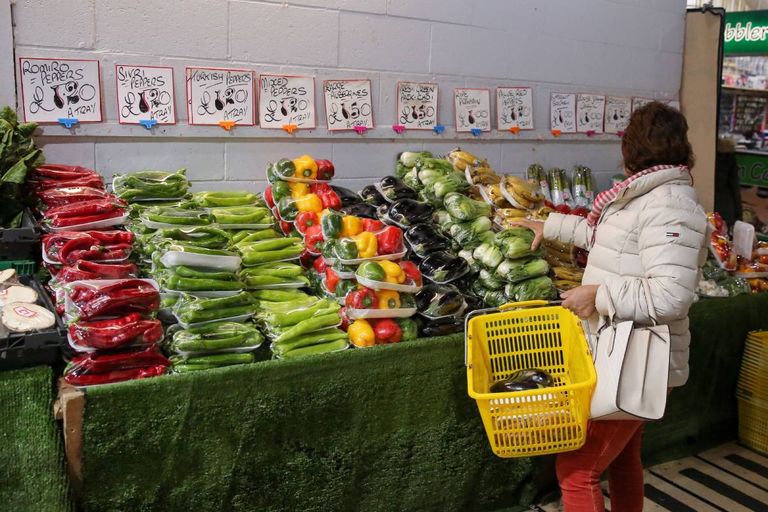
[{"xmin": 736, "ymin": 331, "xmax": 768, "ymax": 453}]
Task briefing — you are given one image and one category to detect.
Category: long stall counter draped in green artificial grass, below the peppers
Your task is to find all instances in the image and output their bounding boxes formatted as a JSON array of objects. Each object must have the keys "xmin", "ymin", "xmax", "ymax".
[{"xmin": 49, "ymin": 294, "xmax": 768, "ymax": 511}]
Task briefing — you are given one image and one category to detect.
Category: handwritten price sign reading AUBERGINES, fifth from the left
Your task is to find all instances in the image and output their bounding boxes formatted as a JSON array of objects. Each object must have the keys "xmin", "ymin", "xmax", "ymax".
[{"xmin": 323, "ymin": 80, "xmax": 373, "ymax": 131}]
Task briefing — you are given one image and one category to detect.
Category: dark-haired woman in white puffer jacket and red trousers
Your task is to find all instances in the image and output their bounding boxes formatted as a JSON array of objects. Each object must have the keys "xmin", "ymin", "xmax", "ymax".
[{"xmin": 519, "ymin": 102, "xmax": 707, "ymax": 512}]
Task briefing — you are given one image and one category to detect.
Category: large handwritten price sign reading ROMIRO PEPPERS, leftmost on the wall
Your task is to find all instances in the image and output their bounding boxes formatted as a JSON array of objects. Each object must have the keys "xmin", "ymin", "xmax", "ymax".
[{"xmin": 19, "ymin": 57, "xmax": 102, "ymax": 123}]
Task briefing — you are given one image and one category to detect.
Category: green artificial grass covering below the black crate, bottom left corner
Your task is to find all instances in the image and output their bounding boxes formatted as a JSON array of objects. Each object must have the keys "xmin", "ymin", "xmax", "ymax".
[{"xmin": 0, "ymin": 367, "xmax": 71, "ymax": 512}]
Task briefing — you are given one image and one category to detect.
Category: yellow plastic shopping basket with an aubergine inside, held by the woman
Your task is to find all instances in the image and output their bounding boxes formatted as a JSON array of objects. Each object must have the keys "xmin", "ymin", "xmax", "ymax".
[{"xmin": 465, "ymin": 301, "xmax": 597, "ymax": 458}]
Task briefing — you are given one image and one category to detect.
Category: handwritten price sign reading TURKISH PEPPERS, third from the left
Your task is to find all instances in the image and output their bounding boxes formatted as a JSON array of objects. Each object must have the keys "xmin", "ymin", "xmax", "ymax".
[{"xmin": 186, "ymin": 68, "xmax": 256, "ymax": 126}]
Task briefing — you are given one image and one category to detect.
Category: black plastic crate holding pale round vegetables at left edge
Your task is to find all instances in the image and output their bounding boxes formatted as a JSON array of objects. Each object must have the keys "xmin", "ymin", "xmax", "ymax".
[{"xmin": 0, "ymin": 276, "xmax": 68, "ymax": 370}]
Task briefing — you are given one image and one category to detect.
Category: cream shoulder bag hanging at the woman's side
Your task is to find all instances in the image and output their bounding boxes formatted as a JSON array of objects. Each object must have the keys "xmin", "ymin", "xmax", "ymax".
[{"xmin": 590, "ymin": 282, "xmax": 670, "ymax": 420}]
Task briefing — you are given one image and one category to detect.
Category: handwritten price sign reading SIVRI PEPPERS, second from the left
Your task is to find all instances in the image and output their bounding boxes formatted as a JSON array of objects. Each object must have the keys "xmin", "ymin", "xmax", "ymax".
[{"xmin": 115, "ymin": 64, "xmax": 176, "ymax": 124}]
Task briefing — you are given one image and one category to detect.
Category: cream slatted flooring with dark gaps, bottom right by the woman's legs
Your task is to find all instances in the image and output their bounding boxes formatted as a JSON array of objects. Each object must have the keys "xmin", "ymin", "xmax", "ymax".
[{"xmin": 533, "ymin": 443, "xmax": 768, "ymax": 512}]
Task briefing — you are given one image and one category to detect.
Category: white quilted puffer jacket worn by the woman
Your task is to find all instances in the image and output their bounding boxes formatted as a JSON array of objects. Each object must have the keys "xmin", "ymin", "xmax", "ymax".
[{"xmin": 544, "ymin": 168, "xmax": 708, "ymax": 387}]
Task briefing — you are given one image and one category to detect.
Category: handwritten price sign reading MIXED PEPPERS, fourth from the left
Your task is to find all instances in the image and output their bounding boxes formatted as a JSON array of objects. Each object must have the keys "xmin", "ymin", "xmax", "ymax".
[{"xmin": 259, "ymin": 75, "xmax": 316, "ymax": 129}]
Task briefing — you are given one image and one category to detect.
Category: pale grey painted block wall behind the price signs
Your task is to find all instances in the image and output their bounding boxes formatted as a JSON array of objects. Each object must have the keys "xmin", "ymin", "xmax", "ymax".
[{"xmin": 9, "ymin": 0, "xmax": 685, "ymax": 190}]
